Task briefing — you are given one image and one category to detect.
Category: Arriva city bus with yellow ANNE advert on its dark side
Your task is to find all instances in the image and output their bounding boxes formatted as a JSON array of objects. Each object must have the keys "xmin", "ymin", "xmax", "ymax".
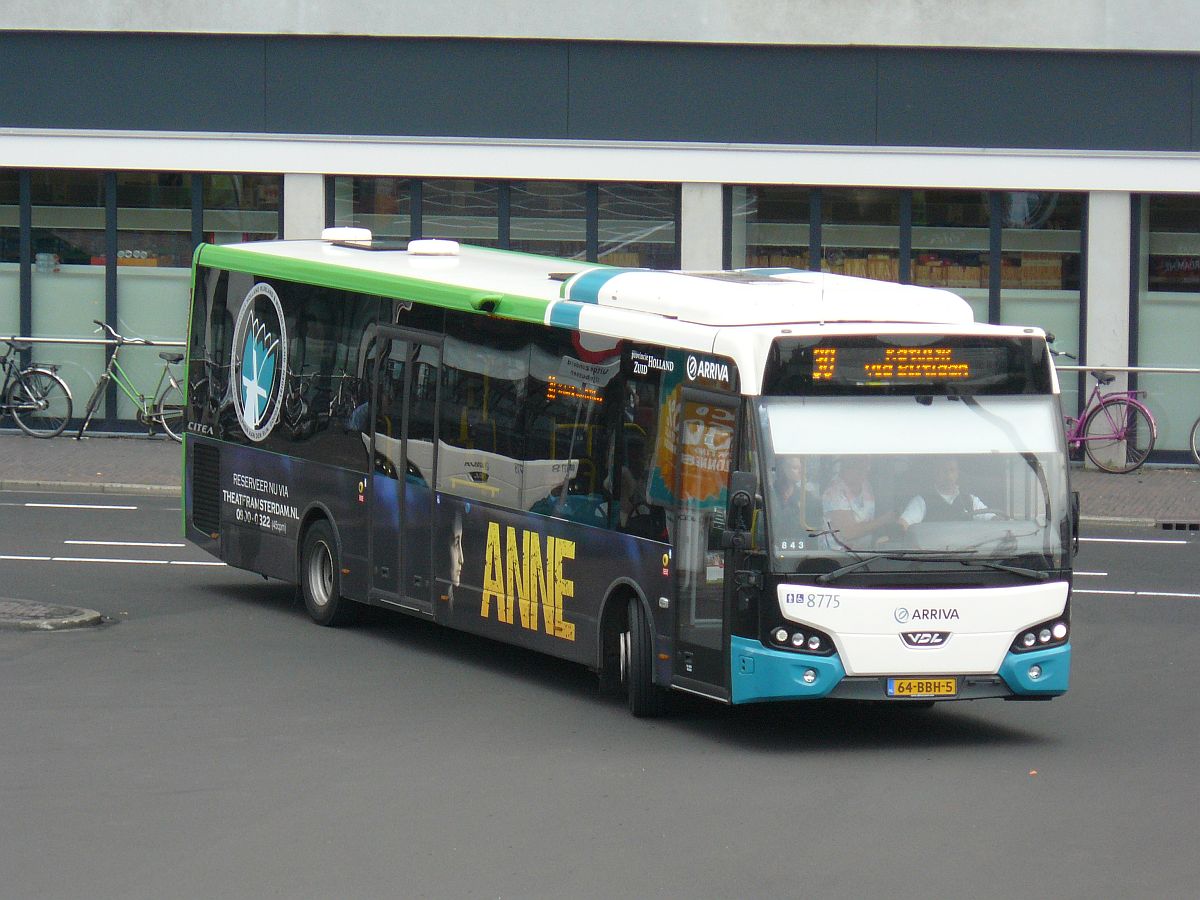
[{"xmin": 184, "ymin": 229, "xmax": 1078, "ymax": 716}]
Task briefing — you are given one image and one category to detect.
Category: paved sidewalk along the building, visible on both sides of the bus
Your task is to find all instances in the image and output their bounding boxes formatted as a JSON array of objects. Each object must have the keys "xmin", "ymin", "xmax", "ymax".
[{"xmin": 0, "ymin": 432, "xmax": 1200, "ymax": 527}]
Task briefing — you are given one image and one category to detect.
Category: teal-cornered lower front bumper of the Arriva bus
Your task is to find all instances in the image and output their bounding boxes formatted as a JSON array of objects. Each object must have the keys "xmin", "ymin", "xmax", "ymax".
[{"xmin": 730, "ymin": 637, "xmax": 1070, "ymax": 703}]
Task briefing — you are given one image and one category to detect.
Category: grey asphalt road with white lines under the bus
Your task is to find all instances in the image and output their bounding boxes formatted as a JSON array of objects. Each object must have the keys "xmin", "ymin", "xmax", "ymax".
[{"xmin": 0, "ymin": 492, "xmax": 1200, "ymax": 900}]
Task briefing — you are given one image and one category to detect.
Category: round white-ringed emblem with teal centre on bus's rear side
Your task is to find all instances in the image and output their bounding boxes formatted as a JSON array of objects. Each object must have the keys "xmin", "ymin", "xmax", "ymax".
[{"xmin": 229, "ymin": 282, "xmax": 288, "ymax": 442}]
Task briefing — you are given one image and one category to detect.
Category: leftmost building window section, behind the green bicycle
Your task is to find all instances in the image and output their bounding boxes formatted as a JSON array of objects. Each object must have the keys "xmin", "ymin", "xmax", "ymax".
[{"xmin": 0, "ymin": 169, "xmax": 283, "ymax": 428}]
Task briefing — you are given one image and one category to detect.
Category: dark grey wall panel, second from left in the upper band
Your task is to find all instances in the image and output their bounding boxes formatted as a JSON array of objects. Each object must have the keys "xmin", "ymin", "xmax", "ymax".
[{"xmin": 265, "ymin": 37, "xmax": 568, "ymax": 138}]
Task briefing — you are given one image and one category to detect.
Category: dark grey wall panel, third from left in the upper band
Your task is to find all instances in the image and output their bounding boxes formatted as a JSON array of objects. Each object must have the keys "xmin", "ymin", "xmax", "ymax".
[{"xmin": 571, "ymin": 43, "xmax": 876, "ymax": 144}]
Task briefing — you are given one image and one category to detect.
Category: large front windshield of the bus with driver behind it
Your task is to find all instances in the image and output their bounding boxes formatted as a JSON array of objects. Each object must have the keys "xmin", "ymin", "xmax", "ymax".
[{"xmin": 758, "ymin": 395, "xmax": 1069, "ymax": 571}]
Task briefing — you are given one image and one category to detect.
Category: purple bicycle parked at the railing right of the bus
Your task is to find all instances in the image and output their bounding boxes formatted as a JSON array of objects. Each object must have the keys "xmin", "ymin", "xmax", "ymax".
[{"xmin": 1055, "ymin": 350, "xmax": 1158, "ymax": 474}]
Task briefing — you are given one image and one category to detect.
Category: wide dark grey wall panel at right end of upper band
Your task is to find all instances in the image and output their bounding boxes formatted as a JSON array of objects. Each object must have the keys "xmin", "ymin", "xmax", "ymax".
[{"xmin": 878, "ymin": 50, "xmax": 1196, "ymax": 150}]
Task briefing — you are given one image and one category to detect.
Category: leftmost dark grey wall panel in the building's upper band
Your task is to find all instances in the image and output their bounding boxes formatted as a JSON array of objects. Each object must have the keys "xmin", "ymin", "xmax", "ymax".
[{"xmin": 0, "ymin": 32, "xmax": 264, "ymax": 132}]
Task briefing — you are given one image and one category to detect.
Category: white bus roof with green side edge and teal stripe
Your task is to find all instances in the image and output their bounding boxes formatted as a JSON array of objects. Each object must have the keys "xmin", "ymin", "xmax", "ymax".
[{"xmin": 196, "ymin": 236, "xmax": 973, "ymax": 334}]
